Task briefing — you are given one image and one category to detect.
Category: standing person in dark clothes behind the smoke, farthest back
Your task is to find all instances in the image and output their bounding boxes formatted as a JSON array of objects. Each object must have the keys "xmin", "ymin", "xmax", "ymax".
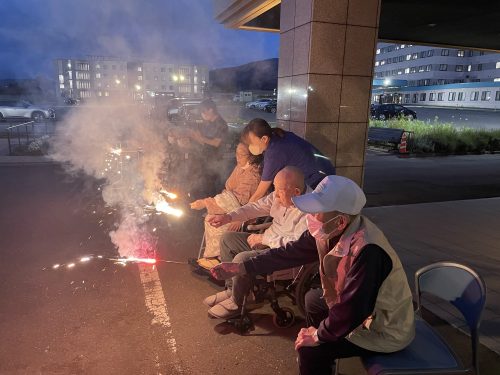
[{"xmin": 189, "ymin": 99, "xmax": 229, "ymax": 196}]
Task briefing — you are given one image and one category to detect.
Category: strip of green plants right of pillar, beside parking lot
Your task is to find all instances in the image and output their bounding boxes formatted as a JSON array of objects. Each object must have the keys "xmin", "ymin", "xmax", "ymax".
[{"xmin": 370, "ymin": 118, "xmax": 500, "ymax": 154}]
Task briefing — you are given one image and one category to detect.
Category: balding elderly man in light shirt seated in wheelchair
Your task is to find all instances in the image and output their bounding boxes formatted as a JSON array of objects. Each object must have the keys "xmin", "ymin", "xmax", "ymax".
[{"xmin": 204, "ymin": 166, "xmax": 311, "ymax": 319}]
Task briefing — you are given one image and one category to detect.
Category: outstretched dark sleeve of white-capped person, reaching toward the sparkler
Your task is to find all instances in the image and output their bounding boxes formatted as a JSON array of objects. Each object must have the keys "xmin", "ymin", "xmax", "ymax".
[{"xmin": 243, "ymin": 231, "xmax": 318, "ymax": 274}]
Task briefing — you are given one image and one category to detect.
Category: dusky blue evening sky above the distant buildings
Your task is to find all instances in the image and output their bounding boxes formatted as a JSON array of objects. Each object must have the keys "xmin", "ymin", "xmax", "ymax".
[{"xmin": 0, "ymin": 0, "xmax": 279, "ymax": 79}]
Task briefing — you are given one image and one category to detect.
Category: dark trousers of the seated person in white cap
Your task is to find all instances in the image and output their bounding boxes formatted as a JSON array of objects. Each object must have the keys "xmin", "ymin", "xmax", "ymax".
[{"xmin": 299, "ymin": 289, "xmax": 380, "ymax": 375}]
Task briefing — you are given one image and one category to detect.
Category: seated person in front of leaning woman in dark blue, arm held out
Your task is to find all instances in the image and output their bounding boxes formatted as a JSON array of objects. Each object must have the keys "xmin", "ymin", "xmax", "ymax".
[{"xmin": 191, "ymin": 143, "xmax": 260, "ymax": 269}]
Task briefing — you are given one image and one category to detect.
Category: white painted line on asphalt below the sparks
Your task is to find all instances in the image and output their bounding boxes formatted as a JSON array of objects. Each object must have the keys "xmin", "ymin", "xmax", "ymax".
[{"xmin": 139, "ymin": 264, "xmax": 182, "ymax": 373}]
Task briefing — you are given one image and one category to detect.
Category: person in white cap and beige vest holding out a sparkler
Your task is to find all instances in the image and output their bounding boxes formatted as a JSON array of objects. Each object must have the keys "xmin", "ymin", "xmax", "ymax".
[{"xmin": 211, "ymin": 176, "xmax": 415, "ymax": 375}]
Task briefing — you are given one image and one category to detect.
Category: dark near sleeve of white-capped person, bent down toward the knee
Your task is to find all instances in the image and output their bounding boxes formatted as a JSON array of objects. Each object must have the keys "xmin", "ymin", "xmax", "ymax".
[{"xmin": 317, "ymin": 245, "xmax": 392, "ymax": 342}]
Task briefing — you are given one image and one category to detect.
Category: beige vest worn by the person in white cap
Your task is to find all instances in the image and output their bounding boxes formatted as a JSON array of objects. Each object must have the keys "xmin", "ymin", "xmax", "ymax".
[{"xmin": 316, "ymin": 216, "xmax": 415, "ymax": 353}]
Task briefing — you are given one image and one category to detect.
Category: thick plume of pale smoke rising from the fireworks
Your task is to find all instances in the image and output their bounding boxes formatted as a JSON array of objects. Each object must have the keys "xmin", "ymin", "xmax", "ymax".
[{"xmin": 50, "ymin": 102, "xmax": 168, "ymax": 257}]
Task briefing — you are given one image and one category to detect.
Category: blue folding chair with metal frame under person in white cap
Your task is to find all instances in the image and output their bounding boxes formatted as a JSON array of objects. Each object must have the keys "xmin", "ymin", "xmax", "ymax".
[{"xmin": 360, "ymin": 262, "xmax": 486, "ymax": 375}]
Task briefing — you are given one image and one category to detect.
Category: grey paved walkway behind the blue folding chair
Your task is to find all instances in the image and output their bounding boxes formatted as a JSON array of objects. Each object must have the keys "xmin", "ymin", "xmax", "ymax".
[{"xmin": 363, "ymin": 198, "xmax": 500, "ymax": 354}]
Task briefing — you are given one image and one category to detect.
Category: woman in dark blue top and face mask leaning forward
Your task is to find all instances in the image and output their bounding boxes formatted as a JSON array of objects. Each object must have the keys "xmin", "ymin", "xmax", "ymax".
[{"xmin": 242, "ymin": 118, "xmax": 335, "ymax": 202}]
